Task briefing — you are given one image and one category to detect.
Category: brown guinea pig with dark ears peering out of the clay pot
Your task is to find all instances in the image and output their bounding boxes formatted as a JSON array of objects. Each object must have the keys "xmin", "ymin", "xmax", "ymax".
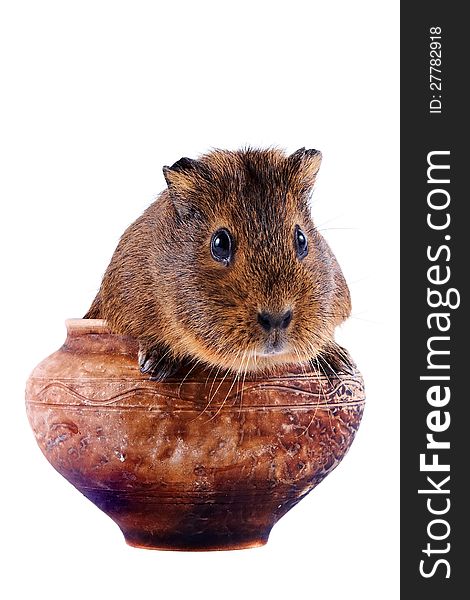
[{"xmin": 85, "ymin": 148, "xmax": 351, "ymax": 380}]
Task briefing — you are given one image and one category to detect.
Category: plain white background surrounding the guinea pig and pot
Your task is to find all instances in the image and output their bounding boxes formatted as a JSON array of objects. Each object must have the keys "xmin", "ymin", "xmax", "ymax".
[{"xmin": 0, "ymin": 0, "xmax": 399, "ymax": 600}]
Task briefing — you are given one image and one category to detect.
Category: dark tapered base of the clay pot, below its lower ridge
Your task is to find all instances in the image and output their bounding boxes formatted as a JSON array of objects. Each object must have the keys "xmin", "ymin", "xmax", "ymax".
[{"xmin": 80, "ymin": 486, "xmax": 280, "ymax": 551}]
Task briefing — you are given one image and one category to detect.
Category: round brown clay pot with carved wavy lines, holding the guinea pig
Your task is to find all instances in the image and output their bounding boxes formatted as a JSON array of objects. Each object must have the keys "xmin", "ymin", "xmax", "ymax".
[{"xmin": 26, "ymin": 319, "xmax": 364, "ymax": 550}]
